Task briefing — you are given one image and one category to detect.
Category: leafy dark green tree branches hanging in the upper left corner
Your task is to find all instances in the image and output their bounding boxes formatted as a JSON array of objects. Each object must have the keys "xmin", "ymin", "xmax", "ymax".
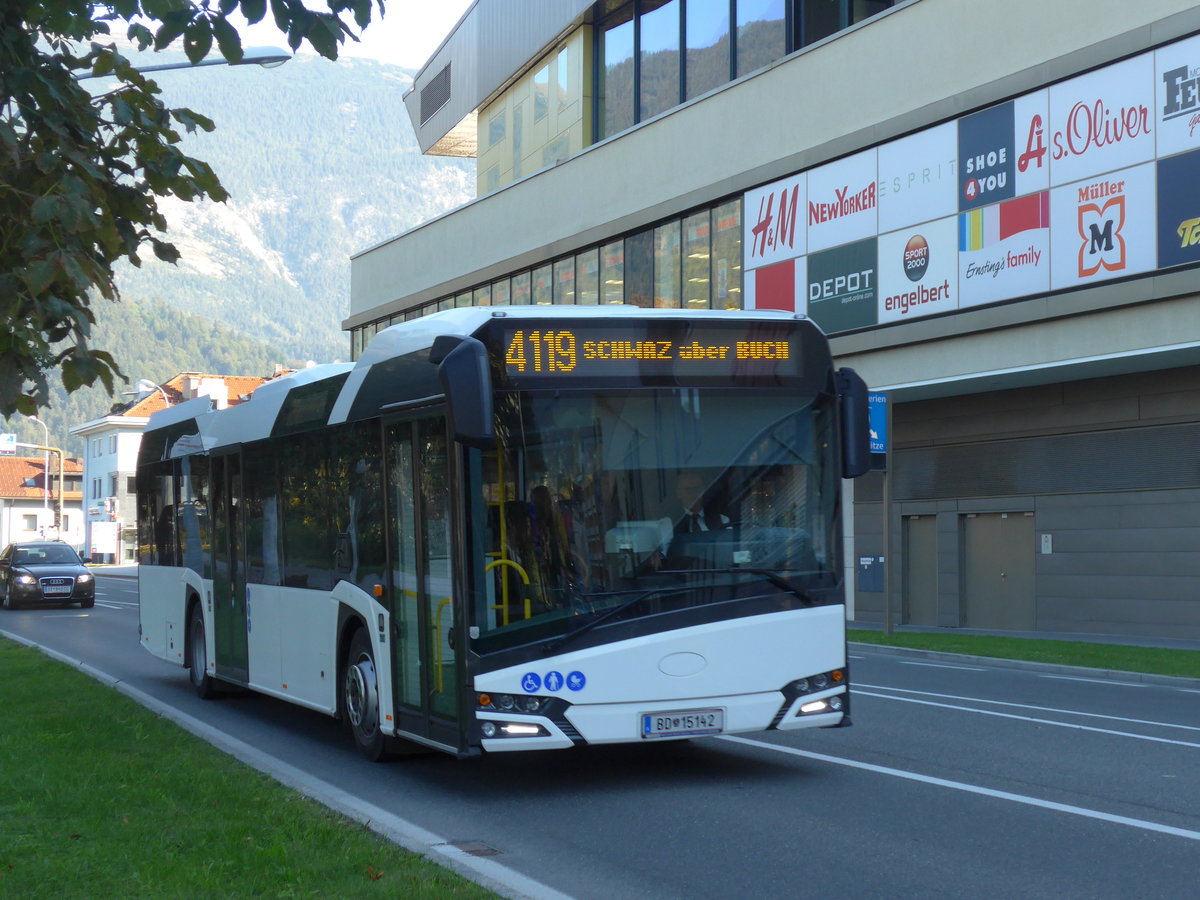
[{"xmin": 0, "ymin": 0, "xmax": 384, "ymax": 415}]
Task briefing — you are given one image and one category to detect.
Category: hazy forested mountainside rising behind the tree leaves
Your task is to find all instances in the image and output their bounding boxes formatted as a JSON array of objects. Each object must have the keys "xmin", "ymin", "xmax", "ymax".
[{"xmin": 11, "ymin": 48, "xmax": 474, "ymax": 454}]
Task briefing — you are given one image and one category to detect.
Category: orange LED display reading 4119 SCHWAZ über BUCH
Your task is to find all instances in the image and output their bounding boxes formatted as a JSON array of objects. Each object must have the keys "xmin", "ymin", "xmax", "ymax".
[{"xmin": 500, "ymin": 325, "xmax": 800, "ymax": 380}]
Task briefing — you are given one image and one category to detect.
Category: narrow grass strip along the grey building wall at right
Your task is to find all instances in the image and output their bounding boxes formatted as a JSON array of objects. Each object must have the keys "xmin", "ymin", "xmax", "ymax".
[{"xmin": 847, "ymin": 629, "xmax": 1200, "ymax": 678}]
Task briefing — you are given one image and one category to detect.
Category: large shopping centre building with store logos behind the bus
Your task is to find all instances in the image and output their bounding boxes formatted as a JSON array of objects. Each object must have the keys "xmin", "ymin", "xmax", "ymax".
[{"xmin": 344, "ymin": 0, "xmax": 1200, "ymax": 640}]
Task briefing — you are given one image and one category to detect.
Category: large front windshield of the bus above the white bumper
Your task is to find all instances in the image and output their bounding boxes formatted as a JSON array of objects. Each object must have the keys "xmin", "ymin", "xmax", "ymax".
[{"xmin": 474, "ymin": 389, "xmax": 838, "ymax": 653}]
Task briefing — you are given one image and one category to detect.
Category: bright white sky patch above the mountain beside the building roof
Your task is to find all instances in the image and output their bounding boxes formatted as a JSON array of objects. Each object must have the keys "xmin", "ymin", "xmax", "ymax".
[{"xmin": 239, "ymin": 0, "xmax": 473, "ymax": 68}]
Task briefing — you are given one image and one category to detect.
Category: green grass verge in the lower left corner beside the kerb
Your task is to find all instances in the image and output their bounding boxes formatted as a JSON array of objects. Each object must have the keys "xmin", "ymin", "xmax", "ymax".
[{"xmin": 0, "ymin": 638, "xmax": 494, "ymax": 900}]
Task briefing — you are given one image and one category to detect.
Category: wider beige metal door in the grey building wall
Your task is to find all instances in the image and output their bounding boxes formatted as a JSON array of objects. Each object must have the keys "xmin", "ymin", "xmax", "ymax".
[{"xmin": 962, "ymin": 512, "xmax": 1037, "ymax": 631}]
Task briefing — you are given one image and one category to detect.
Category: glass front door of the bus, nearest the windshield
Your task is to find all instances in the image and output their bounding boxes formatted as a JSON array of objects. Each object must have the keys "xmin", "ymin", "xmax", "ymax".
[{"xmin": 384, "ymin": 416, "xmax": 462, "ymax": 750}]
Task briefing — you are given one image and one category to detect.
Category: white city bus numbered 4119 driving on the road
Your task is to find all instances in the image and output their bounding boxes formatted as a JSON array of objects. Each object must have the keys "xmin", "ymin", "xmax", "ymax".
[{"xmin": 138, "ymin": 307, "xmax": 869, "ymax": 758}]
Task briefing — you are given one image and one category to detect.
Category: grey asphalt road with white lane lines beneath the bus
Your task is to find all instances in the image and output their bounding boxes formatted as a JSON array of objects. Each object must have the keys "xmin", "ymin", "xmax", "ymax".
[{"xmin": 0, "ymin": 576, "xmax": 1200, "ymax": 900}]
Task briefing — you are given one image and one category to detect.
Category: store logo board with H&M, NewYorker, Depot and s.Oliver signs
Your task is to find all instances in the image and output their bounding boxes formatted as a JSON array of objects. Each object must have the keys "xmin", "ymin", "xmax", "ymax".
[{"xmin": 743, "ymin": 36, "xmax": 1200, "ymax": 332}]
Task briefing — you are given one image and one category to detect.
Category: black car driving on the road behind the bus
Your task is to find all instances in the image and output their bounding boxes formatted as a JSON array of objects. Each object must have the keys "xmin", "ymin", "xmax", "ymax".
[{"xmin": 0, "ymin": 541, "xmax": 96, "ymax": 610}]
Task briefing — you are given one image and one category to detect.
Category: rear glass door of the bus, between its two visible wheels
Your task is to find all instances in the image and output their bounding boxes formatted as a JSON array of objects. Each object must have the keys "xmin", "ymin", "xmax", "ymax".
[{"xmin": 212, "ymin": 454, "xmax": 250, "ymax": 682}]
